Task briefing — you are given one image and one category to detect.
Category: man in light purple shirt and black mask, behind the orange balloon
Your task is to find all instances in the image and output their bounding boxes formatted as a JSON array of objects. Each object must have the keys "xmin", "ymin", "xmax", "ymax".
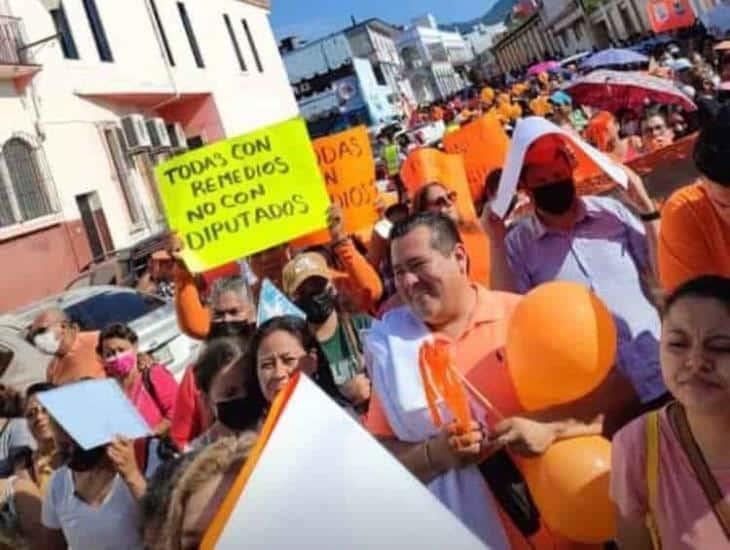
[{"xmin": 494, "ymin": 136, "xmax": 666, "ymax": 433}]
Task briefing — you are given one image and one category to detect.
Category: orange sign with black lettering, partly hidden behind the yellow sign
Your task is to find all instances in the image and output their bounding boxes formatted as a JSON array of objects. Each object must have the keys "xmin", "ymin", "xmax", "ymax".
[{"xmin": 292, "ymin": 126, "xmax": 378, "ymax": 248}]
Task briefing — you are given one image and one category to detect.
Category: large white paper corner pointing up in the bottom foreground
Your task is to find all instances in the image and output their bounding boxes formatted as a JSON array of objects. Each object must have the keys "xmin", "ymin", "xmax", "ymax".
[{"xmin": 216, "ymin": 377, "xmax": 485, "ymax": 550}]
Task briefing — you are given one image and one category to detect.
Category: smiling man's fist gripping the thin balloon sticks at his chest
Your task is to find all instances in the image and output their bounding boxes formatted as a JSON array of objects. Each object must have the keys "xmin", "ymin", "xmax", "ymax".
[{"xmin": 428, "ymin": 422, "xmax": 486, "ymax": 472}]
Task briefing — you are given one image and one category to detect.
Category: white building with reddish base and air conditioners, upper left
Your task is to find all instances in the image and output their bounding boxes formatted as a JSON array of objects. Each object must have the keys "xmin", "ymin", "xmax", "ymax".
[{"xmin": 0, "ymin": 0, "xmax": 297, "ymax": 310}]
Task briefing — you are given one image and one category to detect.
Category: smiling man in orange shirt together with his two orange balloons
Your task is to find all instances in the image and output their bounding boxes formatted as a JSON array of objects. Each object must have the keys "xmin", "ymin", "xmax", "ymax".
[{"xmin": 365, "ymin": 214, "xmax": 616, "ymax": 548}]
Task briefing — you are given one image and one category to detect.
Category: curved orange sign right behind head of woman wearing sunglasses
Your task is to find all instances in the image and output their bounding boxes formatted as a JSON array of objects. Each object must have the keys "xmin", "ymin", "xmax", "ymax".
[{"xmin": 400, "ymin": 148, "xmax": 477, "ymax": 220}]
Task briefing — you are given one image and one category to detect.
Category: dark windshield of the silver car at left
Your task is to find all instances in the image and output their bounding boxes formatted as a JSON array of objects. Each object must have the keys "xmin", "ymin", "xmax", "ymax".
[{"xmin": 64, "ymin": 291, "xmax": 165, "ymax": 330}]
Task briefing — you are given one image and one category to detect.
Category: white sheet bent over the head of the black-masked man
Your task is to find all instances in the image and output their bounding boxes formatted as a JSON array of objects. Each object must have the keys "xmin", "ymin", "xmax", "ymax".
[{"xmin": 492, "ymin": 116, "xmax": 629, "ymax": 218}]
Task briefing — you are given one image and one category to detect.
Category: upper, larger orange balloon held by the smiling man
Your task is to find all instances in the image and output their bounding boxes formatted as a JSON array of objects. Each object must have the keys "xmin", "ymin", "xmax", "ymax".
[{"xmin": 506, "ymin": 281, "xmax": 616, "ymax": 411}]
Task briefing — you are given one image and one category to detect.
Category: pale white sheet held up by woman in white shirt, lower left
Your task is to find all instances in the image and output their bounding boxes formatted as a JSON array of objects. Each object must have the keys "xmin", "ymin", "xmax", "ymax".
[{"xmin": 37, "ymin": 378, "xmax": 152, "ymax": 450}]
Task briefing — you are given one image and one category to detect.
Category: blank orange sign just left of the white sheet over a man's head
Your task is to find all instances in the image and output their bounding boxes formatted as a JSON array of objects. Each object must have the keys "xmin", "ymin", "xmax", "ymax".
[{"xmin": 443, "ymin": 112, "xmax": 509, "ymax": 201}]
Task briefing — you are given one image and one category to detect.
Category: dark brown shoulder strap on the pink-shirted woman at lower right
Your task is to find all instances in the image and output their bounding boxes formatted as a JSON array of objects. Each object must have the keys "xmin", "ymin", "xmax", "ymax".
[{"xmin": 668, "ymin": 404, "xmax": 730, "ymax": 541}]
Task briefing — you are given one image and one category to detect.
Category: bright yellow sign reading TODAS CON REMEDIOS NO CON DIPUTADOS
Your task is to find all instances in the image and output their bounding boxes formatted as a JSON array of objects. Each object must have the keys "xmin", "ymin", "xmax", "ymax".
[{"xmin": 156, "ymin": 118, "xmax": 329, "ymax": 272}]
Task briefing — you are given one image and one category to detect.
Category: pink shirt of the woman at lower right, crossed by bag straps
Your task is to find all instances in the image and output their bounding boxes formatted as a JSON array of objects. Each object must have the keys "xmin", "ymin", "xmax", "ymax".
[{"xmin": 611, "ymin": 410, "xmax": 730, "ymax": 550}]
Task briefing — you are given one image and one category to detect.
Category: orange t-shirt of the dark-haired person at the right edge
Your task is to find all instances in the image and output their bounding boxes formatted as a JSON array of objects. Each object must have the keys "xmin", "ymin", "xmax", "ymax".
[{"xmin": 658, "ymin": 183, "xmax": 730, "ymax": 292}]
